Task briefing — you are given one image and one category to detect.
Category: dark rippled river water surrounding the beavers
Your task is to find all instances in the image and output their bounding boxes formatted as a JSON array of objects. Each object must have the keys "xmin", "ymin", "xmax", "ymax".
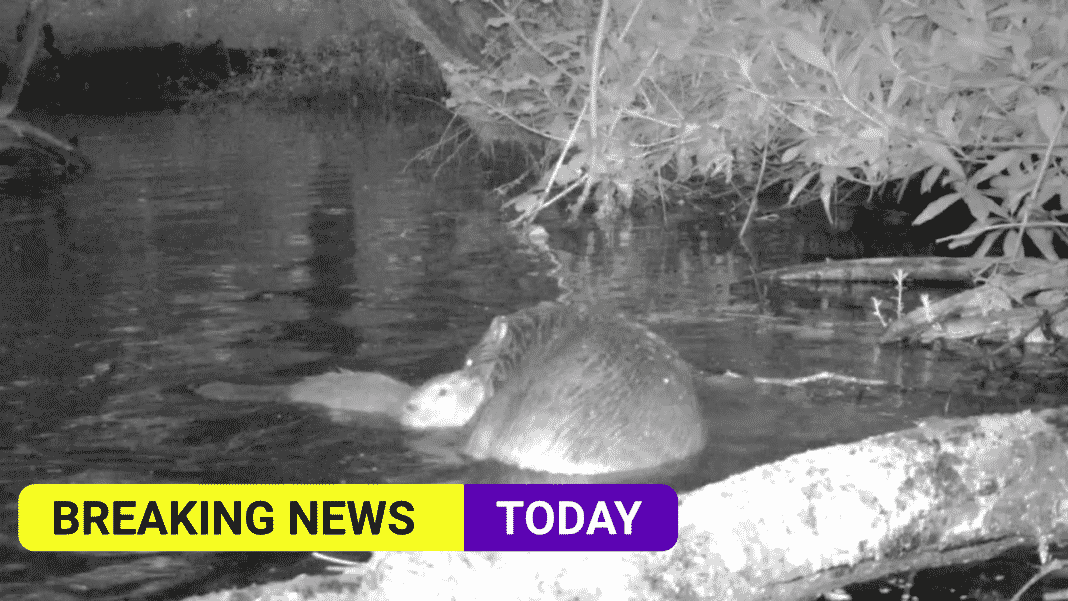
[{"xmin": 0, "ymin": 107, "xmax": 1046, "ymax": 599}]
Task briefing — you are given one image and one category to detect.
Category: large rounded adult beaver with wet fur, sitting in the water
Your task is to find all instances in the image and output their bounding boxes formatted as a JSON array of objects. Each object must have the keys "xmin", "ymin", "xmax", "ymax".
[{"xmin": 461, "ymin": 303, "xmax": 707, "ymax": 475}]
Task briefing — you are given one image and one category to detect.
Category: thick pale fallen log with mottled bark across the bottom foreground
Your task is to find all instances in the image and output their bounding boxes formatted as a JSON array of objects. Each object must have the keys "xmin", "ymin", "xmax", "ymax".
[{"xmin": 358, "ymin": 409, "xmax": 1068, "ymax": 600}]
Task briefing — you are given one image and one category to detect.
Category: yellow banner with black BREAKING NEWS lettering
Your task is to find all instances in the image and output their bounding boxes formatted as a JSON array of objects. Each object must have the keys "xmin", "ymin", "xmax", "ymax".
[{"xmin": 18, "ymin": 484, "xmax": 464, "ymax": 551}]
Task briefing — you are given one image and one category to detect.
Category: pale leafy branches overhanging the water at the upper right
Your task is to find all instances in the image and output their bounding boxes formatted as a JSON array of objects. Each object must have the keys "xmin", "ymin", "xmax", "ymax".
[{"xmin": 446, "ymin": 0, "xmax": 1068, "ymax": 256}]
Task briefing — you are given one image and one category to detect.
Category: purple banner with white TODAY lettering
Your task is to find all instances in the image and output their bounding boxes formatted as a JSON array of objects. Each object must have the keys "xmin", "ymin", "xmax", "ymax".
[{"xmin": 464, "ymin": 485, "xmax": 678, "ymax": 551}]
